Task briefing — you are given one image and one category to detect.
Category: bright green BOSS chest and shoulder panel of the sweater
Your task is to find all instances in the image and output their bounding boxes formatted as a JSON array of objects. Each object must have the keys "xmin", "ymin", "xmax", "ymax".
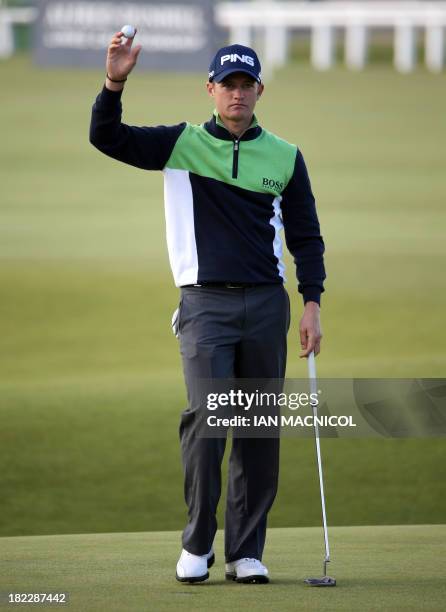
[{"xmin": 166, "ymin": 123, "xmax": 297, "ymax": 195}]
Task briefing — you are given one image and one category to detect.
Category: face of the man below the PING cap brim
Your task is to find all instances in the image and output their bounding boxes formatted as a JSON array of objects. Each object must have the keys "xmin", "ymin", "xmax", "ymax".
[{"xmin": 207, "ymin": 72, "xmax": 263, "ymax": 122}]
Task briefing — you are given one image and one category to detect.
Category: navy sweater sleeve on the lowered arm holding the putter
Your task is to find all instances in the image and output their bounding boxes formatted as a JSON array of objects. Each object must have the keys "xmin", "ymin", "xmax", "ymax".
[{"xmin": 282, "ymin": 150, "xmax": 326, "ymax": 303}]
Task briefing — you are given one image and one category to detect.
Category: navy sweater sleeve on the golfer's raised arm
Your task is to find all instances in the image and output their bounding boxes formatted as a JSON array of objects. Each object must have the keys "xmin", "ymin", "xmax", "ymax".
[{"xmin": 90, "ymin": 86, "xmax": 186, "ymax": 170}]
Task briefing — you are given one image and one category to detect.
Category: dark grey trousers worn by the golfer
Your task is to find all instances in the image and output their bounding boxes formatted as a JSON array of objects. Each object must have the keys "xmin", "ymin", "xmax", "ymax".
[{"xmin": 178, "ymin": 284, "xmax": 290, "ymax": 562}]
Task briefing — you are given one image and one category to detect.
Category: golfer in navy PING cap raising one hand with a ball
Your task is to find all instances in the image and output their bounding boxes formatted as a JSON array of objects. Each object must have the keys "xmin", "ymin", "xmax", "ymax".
[{"xmin": 90, "ymin": 32, "xmax": 325, "ymax": 583}]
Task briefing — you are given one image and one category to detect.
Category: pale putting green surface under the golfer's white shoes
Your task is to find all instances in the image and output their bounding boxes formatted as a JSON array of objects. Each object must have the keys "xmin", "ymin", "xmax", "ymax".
[{"xmin": 0, "ymin": 525, "xmax": 446, "ymax": 612}]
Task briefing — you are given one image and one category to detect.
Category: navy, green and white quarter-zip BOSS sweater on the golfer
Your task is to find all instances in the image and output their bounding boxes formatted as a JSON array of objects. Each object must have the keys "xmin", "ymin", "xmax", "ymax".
[{"xmin": 90, "ymin": 87, "xmax": 325, "ymax": 302}]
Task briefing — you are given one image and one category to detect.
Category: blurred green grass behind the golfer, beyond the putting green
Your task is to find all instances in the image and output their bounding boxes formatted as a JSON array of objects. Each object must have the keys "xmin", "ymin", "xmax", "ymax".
[{"xmin": 0, "ymin": 55, "xmax": 446, "ymax": 535}]
